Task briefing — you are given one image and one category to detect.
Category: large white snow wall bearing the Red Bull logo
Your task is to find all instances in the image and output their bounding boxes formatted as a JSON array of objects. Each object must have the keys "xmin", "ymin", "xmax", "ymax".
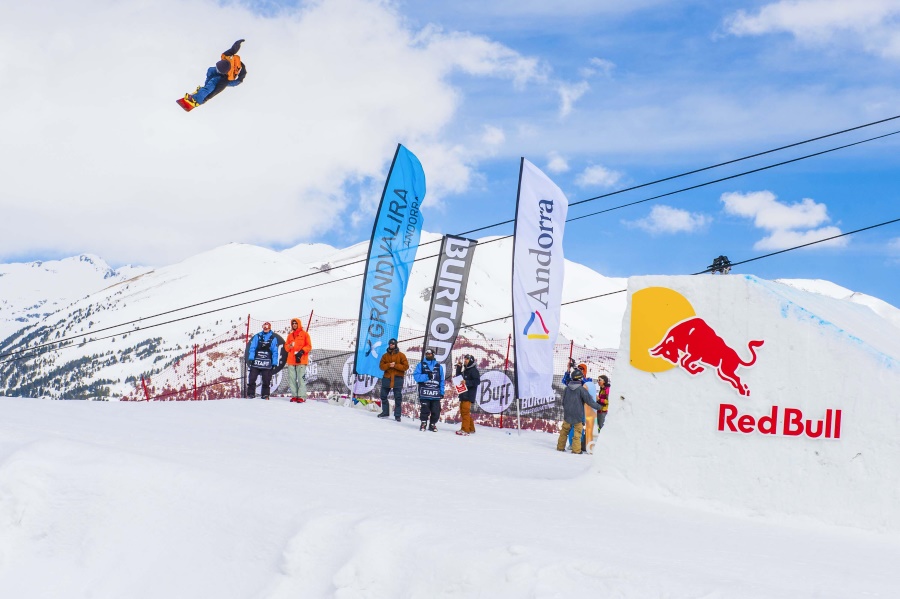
[{"xmin": 595, "ymin": 275, "xmax": 900, "ymax": 531}]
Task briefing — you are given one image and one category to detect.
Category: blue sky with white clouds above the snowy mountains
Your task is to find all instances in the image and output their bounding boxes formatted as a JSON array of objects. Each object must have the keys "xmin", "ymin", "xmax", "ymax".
[{"xmin": 0, "ymin": 0, "xmax": 900, "ymax": 305}]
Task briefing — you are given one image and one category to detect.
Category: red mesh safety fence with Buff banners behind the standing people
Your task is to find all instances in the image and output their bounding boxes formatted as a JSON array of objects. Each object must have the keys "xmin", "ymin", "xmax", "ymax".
[{"xmin": 123, "ymin": 314, "xmax": 616, "ymax": 432}]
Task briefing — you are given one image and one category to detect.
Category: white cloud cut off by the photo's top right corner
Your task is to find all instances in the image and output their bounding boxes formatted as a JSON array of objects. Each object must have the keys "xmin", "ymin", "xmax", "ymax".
[{"xmin": 725, "ymin": 0, "xmax": 900, "ymax": 59}]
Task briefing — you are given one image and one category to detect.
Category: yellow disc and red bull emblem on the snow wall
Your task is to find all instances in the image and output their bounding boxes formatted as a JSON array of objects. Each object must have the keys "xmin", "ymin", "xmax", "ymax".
[{"xmin": 630, "ymin": 287, "xmax": 764, "ymax": 396}]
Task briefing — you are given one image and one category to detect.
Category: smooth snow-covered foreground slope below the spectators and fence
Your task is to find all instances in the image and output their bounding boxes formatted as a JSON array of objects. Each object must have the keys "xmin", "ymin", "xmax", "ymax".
[{"xmin": 0, "ymin": 399, "xmax": 900, "ymax": 599}]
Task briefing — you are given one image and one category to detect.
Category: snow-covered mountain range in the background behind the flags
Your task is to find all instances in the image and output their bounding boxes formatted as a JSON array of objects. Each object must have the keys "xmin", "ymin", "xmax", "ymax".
[{"xmin": 0, "ymin": 232, "xmax": 900, "ymax": 397}]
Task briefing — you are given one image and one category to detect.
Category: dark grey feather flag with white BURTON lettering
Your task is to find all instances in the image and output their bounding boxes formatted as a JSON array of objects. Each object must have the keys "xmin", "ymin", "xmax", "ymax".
[{"xmin": 423, "ymin": 235, "xmax": 478, "ymax": 372}]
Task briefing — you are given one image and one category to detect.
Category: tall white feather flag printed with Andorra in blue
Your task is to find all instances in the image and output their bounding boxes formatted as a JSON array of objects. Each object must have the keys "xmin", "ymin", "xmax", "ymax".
[{"xmin": 512, "ymin": 158, "xmax": 569, "ymax": 413}]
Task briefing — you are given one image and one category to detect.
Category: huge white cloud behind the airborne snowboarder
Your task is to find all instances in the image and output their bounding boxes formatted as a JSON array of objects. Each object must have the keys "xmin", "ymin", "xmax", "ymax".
[{"xmin": 0, "ymin": 0, "xmax": 547, "ymax": 264}]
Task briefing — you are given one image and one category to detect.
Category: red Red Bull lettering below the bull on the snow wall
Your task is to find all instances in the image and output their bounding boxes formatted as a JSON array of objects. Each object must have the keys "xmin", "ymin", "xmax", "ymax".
[{"xmin": 719, "ymin": 403, "xmax": 841, "ymax": 439}]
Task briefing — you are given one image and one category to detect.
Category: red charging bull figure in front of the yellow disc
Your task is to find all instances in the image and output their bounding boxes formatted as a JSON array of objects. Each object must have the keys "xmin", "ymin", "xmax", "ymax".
[{"xmin": 650, "ymin": 317, "xmax": 764, "ymax": 396}]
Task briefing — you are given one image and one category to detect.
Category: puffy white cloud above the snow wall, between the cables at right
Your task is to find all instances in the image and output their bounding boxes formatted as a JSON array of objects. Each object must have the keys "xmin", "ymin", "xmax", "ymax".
[{"xmin": 720, "ymin": 191, "xmax": 848, "ymax": 250}]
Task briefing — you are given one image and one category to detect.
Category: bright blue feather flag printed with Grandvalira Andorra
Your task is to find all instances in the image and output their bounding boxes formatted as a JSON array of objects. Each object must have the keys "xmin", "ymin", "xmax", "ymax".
[{"xmin": 353, "ymin": 144, "xmax": 425, "ymax": 377}]
